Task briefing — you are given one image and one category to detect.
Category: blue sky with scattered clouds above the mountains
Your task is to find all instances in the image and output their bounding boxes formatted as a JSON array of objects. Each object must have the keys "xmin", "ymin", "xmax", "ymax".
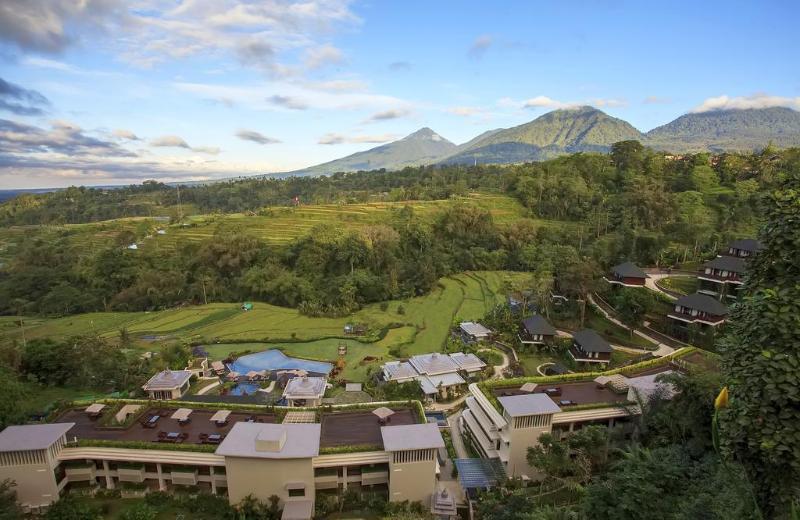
[{"xmin": 0, "ymin": 0, "xmax": 800, "ymax": 189}]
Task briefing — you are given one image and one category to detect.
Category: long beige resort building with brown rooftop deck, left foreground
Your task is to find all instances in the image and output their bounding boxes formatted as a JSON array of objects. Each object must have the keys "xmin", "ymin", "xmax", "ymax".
[{"xmin": 0, "ymin": 401, "xmax": 444, "ymax": 519}]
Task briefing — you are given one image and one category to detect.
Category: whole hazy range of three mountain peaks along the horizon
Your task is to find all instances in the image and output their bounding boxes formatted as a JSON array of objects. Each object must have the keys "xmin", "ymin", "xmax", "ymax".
[{"xmin": 282, "ymin": 106, "xmax": 800, "ymax": 177}]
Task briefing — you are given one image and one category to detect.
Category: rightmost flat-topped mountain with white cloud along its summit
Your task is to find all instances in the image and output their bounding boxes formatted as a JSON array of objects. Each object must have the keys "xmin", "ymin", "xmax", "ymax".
[{"xmin": 644, "ymin": 107, "xmax": 800, "ymax": 152}]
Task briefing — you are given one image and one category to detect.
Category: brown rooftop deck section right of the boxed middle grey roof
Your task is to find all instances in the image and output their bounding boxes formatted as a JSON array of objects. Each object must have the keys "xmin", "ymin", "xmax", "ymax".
[{"xmin": 320, "ymin": 408, "xmax": 417, "ymax": 448}]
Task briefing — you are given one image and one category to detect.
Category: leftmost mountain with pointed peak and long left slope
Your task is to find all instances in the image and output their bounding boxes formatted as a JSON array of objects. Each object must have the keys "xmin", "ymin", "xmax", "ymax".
[{"xmin": 282, "ymin": 127, "xmax": 458, "ymax": 176}]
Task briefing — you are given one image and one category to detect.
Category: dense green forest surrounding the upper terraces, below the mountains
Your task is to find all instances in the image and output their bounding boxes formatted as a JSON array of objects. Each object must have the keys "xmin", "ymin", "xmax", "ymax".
[{"xmin": 0, "ymin": 141, "xmax": 788, "ymax": 316}]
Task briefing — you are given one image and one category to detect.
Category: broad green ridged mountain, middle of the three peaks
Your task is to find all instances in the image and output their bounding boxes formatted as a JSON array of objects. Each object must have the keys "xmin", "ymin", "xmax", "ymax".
[{"xmin": 442, "ymin": 106, "xmax": 642, "ymax": 164}]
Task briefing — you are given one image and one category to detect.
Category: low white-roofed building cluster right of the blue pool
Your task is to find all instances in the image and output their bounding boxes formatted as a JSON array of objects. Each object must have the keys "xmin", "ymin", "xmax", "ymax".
[{"xmin": 383, "ymin": 352, "xmax": 486, "ymax": 399}]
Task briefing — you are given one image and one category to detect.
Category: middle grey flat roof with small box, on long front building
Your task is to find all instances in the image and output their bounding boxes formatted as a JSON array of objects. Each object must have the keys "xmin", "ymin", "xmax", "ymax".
[{"xmin": 215, "ymin": 422, "xmax": 321, "ymax": 459}]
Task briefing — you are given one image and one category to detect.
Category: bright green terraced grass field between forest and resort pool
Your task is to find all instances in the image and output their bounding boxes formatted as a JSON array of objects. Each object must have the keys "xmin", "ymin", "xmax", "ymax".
[{"xmin": 0, "ymin": 271, "xmax": 526, "ymax": 380}]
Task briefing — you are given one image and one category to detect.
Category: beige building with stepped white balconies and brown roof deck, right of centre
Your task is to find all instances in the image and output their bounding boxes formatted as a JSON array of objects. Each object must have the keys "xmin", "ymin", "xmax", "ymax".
[{"xmin": 459, "ymin": 349, "xmax": 704, "ymax": 479}]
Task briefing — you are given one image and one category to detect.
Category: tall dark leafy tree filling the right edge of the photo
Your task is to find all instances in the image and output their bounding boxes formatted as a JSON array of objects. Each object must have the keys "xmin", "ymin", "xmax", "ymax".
[{"xmin": 718, "ymin": 164, "xmax": 800, "ymax": 518}]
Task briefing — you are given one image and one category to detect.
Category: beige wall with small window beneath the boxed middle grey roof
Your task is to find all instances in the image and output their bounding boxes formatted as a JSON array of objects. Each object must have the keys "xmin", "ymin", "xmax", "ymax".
[{"xmin": 225, "ymin": 457, "xmax": 315, "ymax": 504}]
